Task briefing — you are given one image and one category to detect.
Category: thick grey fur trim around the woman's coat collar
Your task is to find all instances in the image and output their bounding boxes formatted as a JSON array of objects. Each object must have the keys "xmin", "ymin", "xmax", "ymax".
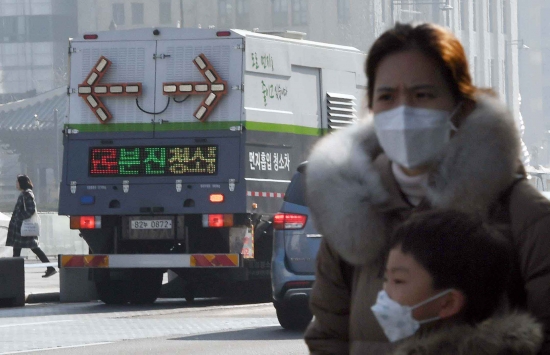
[{"xmin": 306, "ymin": 94, "xmax": 521, "ymax": 264}]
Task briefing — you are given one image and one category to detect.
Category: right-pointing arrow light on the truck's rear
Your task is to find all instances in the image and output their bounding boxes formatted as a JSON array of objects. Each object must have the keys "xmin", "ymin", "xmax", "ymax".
[{"xmin": 162, "ymin": 53, "xmax": 227, "ymax": 122}]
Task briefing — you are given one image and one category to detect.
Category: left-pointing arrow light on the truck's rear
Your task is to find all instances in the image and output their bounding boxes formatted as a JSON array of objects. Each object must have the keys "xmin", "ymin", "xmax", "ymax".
[{"xmin": 78, "ymin": 56, "xmax": 141, "ymax": 123}]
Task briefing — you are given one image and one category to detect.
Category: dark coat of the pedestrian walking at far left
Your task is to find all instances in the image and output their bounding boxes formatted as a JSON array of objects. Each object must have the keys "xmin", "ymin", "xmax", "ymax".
[{"xmin": 6, "ymin": 189, "xmax": 39, "ymax": 249}]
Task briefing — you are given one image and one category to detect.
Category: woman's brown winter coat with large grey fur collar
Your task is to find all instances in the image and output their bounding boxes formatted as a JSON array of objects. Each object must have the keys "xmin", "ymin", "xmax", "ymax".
[{"xmin": 305, "ymin": 96, "xmax": 550, "ymax": 354}]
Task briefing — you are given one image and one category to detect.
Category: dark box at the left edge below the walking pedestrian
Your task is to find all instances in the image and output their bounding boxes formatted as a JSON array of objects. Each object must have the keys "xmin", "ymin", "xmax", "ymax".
[{"xmin": 0, "ymin": 257, "xmax": 25, "ymax": 307}]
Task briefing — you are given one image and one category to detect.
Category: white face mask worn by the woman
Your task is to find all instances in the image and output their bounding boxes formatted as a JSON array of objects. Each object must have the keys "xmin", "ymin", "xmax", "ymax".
[{"xmin": 374, "ymin": 105, "xmax": 460, "ymax": 169}]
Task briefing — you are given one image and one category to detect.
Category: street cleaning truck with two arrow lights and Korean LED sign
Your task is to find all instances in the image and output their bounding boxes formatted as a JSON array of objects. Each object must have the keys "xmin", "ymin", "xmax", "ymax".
[{"xmin": 59, "ymin": 28, "xmax": 366, "ymax": 304}]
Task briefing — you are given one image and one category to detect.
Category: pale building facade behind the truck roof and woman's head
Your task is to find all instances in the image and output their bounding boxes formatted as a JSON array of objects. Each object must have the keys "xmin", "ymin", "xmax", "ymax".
[{"xmin": 79, "ymin": 0, "xmax": 520, "ymax": 117}]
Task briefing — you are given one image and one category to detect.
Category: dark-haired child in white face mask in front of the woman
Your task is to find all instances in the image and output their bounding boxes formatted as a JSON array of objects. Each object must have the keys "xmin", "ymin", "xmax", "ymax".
[{"xmin": 371, "ymin": 210, "xmax": 543, "ymax": 355}]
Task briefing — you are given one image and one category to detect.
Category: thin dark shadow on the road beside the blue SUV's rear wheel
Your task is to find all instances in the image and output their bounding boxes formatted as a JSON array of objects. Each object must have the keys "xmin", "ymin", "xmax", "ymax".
[{"xmin": 168, "ymin": 325, "xmax": 304, "ymax": 341}]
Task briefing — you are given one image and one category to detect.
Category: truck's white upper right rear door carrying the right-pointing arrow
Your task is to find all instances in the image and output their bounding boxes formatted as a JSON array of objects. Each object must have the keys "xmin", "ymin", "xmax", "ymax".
[{"xmin": 155, "ymin": 38, "xmax": 243, "ymax": 130}]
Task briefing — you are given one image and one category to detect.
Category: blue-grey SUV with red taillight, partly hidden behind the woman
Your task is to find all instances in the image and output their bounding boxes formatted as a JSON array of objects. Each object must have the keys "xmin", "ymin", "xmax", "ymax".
[{"xmin": 271, "ymin": 162, "xmax": 321, "ymax": 330}]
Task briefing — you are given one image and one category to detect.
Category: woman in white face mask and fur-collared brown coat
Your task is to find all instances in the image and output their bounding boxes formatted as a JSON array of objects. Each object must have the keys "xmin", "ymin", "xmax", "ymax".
[{"xmin": 305, "ymin": 24, "xmax": 550, "ymax": 354}]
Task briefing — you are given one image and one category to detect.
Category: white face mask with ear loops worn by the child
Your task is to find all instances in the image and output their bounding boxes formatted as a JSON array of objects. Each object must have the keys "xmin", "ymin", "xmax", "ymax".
[{"xmin": 371, "ymin": 289, "xmax": 451, "ymax": 343}]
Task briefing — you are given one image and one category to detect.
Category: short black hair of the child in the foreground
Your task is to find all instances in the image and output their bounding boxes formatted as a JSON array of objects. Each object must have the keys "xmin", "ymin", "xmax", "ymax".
[{"xmin": 390, "ymin": 210, "xmax": 511, "ymax": 323}]
